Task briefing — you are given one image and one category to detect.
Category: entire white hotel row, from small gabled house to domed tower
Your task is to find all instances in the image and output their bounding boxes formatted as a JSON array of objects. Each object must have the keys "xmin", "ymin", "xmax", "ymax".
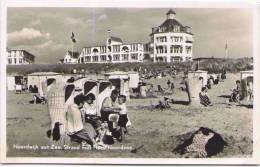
[{"xmin": 62, "ymin": 10, "xmax": 193, "ymax": 64}]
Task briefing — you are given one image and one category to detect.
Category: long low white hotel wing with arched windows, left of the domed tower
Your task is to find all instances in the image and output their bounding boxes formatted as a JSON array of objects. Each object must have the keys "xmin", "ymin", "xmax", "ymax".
[{"xmin": 78, "ymin": 36, "xmax": 148, "ymax": 63}]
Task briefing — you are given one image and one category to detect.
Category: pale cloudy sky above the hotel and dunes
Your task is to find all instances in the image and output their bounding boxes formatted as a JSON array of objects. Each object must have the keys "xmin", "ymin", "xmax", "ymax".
[{"xmin": 7, "ymin": 7, "xmax": 253, "ymax": 63}]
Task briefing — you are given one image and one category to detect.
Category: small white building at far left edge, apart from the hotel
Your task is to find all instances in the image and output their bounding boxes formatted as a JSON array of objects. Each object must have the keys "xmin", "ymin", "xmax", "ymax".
[{"xmin": 7, "ymin": 49, "xmax": 35, "ymax": 65}]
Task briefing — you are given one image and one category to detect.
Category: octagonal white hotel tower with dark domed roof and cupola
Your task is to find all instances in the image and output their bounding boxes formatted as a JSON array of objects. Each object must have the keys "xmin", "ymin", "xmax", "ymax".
[{"xmin": 150, "ymin": 10, "xmax": 193, "ymax": 62}]
